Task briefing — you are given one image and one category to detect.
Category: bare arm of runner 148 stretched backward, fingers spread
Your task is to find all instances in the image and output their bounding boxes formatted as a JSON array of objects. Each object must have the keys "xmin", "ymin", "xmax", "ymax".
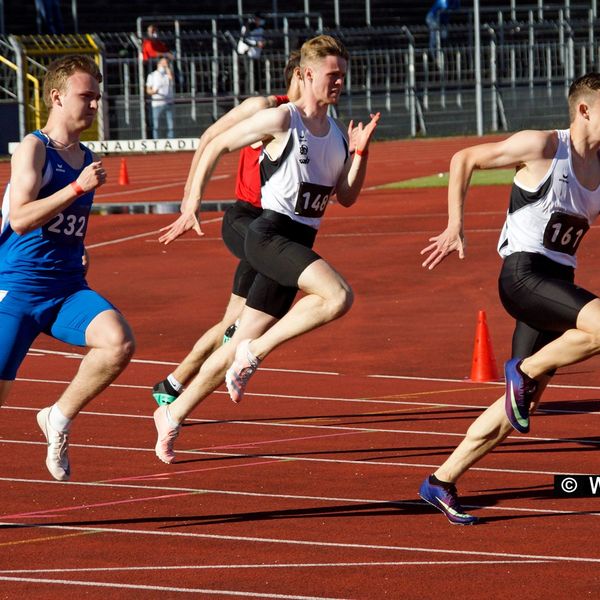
[{"xmin": 158, "ymin": 109, "xmax": 290, "ymax": 245}]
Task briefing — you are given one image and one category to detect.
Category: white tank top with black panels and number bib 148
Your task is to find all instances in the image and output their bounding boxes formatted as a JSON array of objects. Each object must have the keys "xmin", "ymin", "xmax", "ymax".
[{"xmin": 260, "ymin": 102, "xmax": 348, "ymax": 229}]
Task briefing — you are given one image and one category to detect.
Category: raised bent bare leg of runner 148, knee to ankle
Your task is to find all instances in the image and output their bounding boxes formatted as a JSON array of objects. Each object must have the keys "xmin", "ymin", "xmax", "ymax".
[{"xmin": 250, "ymin": 258, "xmax": 353, "ymax": 360}]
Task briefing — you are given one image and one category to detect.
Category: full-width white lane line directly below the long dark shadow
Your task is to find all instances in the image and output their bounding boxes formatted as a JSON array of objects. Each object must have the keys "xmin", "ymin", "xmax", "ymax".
[{"xmin": 0, "ymin": 522, "xmax": 600, "ymax": 563}]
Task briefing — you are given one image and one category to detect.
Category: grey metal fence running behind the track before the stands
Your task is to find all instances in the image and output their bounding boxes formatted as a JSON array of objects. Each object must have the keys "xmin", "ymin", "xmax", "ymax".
[{"xmin": 0, "ymin": 6, "xmax": 600, "ymax": 144}]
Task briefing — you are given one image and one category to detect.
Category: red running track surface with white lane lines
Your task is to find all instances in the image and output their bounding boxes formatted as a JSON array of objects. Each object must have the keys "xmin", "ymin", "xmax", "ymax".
[{"xmin": 0, "ymin": 137, "xmax": 600, "ymax": 599}]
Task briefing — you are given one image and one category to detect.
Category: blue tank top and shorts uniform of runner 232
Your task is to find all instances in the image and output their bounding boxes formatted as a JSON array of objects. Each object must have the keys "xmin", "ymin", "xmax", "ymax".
[{"xmin": 0, "ymin": 131, "xmax": 116, "ymax": 380}]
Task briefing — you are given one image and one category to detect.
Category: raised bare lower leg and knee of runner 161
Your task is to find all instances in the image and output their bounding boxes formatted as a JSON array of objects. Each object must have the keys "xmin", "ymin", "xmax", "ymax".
[{"xmin": 521, "ymin": 298, "xmax": 600, "ymax": 379}]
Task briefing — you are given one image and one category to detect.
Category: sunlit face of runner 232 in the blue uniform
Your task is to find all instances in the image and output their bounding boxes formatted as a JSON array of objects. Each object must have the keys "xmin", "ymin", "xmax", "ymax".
[{"xmin": 52, "ymin": 71, "xmax": 101, "ymax": 129}]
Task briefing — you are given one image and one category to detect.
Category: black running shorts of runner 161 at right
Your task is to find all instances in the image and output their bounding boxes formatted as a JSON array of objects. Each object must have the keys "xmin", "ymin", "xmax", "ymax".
[{"xmin": 498, "ymin": 252, "xmax": 596, "ymax": 358}]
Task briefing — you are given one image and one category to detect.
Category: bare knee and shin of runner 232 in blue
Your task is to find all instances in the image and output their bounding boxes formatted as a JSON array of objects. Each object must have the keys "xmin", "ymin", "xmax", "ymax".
[{"xmin": 57, "ymin": 310, "xmax": 135, "ymax": 419}]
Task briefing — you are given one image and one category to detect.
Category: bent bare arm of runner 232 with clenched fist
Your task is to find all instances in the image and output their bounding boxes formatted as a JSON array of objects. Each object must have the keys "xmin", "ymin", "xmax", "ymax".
[{"xmin": 10, "ymin": 136, "xmax": 106, "ymax": 235}]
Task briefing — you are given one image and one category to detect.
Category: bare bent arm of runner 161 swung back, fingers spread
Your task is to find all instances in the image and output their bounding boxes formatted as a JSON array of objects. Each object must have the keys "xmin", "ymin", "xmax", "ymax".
[{"xmin": 421, "ymin": 131, "xmax": 558, "ymax": 269}]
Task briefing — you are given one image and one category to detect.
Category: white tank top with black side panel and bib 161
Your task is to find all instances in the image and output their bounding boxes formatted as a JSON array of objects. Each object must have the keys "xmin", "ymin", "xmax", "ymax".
[{"xmin": 498, "ymin": 129, "xmax": 600, "ymax": 267}]
